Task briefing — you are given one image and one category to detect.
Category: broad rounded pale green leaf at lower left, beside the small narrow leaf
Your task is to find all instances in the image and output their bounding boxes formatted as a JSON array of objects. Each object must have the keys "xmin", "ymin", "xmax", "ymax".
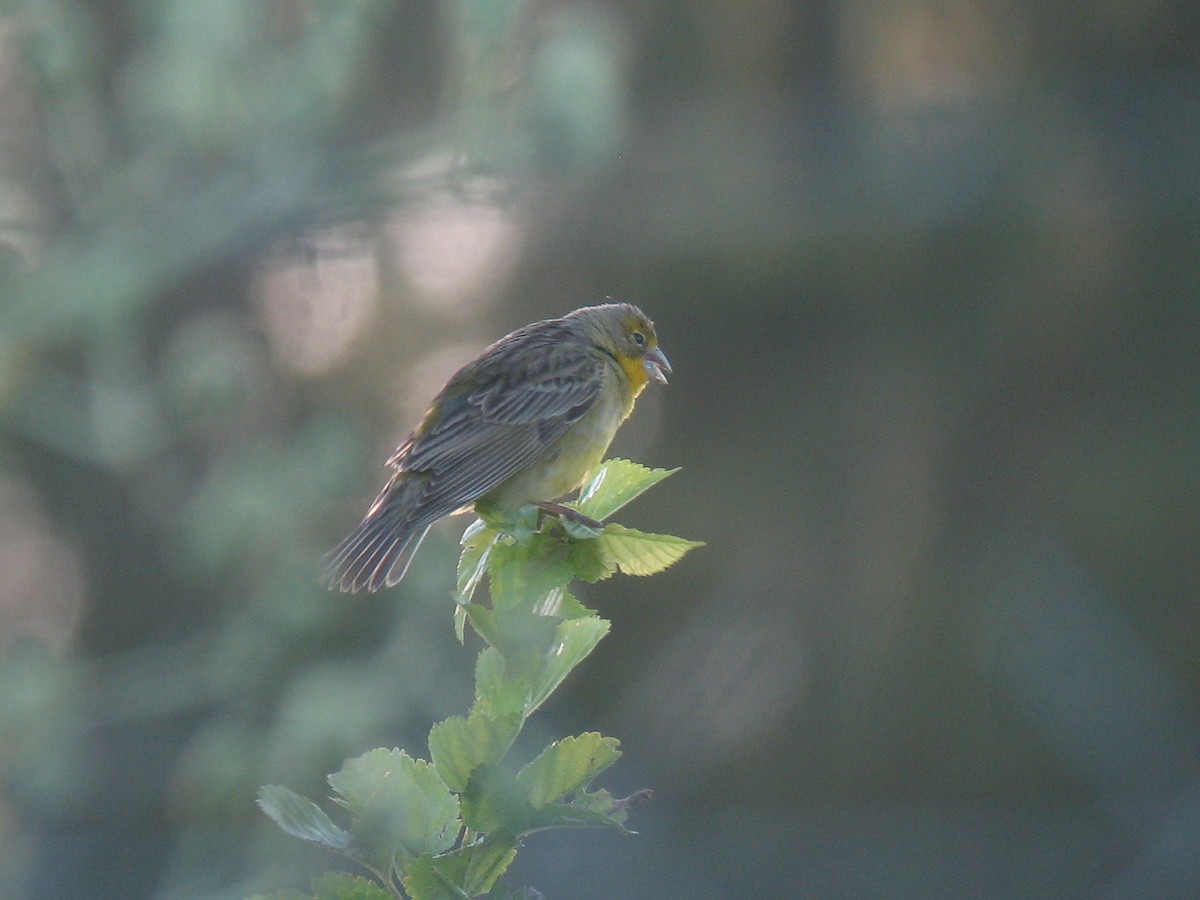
[{"xmin": 329, "ymin": 748, "xmax": 460, "ymax": 872}]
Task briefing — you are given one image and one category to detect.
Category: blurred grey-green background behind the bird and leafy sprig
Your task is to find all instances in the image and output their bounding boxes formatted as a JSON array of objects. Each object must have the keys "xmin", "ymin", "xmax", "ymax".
[{"xmin": 0, "ymin": 0, "xmax": 1200, "ymax": 900}]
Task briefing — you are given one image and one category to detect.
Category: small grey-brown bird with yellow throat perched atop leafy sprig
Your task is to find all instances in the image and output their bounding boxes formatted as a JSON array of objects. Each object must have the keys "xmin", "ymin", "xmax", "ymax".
[{"xmin": 325, "ymin": 304, "xmax": 671, "ymax": 592}]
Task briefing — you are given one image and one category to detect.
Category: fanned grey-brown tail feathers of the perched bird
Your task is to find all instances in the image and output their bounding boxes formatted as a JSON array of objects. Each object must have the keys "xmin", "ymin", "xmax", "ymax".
[{"xmin": 322, "ymin": 475, "xmax": 431, "ymax": 593}]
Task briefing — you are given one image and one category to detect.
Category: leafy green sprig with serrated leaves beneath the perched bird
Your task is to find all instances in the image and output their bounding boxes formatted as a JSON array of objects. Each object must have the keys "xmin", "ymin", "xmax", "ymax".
[{"xmin": 258, "ymin": 460, "xmax": 702, "ymax": 900}]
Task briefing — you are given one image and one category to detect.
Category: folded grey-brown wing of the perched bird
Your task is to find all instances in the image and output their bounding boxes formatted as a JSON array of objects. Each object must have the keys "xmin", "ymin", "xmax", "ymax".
[{"xmin": 389, "ymin": 343, "xmax": 605, "ymax": 521}]
